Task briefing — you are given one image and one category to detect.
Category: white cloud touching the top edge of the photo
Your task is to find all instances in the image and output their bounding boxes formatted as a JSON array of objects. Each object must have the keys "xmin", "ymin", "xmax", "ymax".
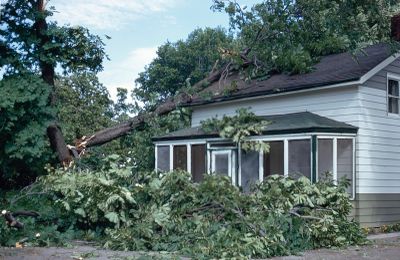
[{"xmin": 50, "ymin": 0, "xmax": 181, "ymax": 30}]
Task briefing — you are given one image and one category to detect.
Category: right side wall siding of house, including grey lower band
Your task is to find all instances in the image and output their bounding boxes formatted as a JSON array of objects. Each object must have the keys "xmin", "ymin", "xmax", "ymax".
[{"xmin": 355, "ymin": 59, "xmax": 400, "ymax": 226}]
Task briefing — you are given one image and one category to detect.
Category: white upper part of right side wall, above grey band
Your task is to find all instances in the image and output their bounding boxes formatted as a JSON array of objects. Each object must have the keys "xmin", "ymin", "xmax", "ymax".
[{"xmin": 357, "ymin": 60, "xmax": 400, "ymax": 193}]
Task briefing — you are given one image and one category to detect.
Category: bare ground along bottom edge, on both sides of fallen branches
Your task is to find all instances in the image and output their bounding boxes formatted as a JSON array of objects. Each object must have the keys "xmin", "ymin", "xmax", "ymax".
[{"xmin": 0, "ymin": 237, "xmax": 400, "ymax": 260}]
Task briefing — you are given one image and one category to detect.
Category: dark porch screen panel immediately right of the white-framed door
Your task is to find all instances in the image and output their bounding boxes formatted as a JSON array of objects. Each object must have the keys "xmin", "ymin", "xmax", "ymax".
[{"xmin": 240, "ymin": 151, "xmax": 260, "ymax": 191}]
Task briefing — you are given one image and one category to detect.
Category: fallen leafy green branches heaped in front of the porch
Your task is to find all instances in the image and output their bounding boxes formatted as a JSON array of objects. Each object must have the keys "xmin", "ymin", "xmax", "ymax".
[{"xmin": 101, "ymin": 172, "xmax": 364, "ymax": 258}]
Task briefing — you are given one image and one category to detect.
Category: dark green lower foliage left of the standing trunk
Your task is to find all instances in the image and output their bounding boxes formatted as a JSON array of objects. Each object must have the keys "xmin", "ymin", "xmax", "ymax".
[{"xmin": 0, "ymin": 75, "xmax": 55, "ymax": 188}]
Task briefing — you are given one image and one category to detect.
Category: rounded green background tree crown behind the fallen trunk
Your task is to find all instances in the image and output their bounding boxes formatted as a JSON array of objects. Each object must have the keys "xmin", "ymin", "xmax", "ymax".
[{"xmin": 134, "ymin": 28, "xmax": 234, "ymax": 105}]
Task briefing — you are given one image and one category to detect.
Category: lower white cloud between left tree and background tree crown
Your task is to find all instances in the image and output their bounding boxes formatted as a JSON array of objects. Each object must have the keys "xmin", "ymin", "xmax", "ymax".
[{"xmin": 99, "ymin": 47, "xmax": 157, "ymax": 100}]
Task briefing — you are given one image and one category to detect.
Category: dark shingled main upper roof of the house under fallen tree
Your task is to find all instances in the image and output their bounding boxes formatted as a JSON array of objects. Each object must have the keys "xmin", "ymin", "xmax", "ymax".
[{"xmin": 183, "ymin": 44, "xmax": 392, "ymax": 106}]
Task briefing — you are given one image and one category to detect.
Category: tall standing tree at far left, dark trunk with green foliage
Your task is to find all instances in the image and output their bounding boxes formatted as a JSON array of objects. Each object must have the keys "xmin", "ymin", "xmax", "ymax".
[{"xmin": 0, "ymin": 0, "xmax": 105, "ymax": 183}]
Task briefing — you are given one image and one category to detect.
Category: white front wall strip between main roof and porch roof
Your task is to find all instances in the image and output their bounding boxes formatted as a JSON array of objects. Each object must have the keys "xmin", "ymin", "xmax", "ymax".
[{"xmin": 192, "ymin": 86, "xmax": 360, "ymax": 126}]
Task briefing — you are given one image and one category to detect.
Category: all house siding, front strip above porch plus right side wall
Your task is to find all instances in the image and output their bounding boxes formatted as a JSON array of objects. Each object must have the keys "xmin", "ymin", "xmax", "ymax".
[{"xmin": 192, "ymin": 56, "xmax": 400, "ymax": 226}]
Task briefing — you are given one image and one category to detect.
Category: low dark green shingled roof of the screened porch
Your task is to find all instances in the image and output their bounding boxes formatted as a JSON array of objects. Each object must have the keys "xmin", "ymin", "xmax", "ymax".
[{"xmin": 153, "ymin": 112, "xmax": 358, "ymax": 141}]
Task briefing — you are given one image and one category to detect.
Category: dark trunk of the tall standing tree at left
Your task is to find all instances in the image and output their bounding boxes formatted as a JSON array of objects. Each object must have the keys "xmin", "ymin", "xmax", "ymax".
[{"xmin": 34, "ymin": 0, "xmax": 72, "ymax": 166}]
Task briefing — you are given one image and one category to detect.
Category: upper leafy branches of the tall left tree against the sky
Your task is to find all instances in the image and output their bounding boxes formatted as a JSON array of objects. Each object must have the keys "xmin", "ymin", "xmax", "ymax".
[{"xmin": 0, "ymin": 0, "xmax": 106, "ymax": 75}]
